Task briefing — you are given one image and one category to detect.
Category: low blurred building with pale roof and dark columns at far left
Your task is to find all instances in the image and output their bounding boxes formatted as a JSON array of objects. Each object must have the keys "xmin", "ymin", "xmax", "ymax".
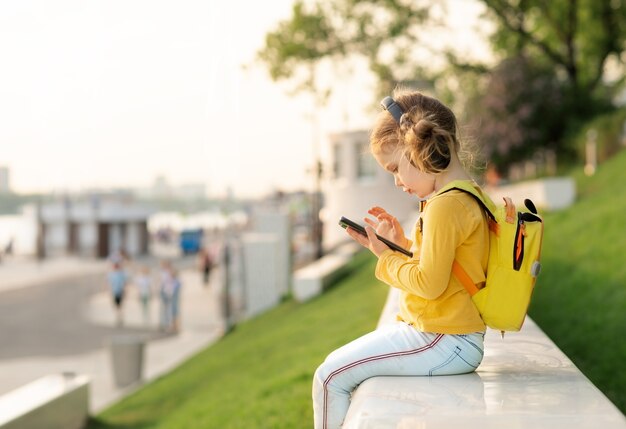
[{"xmin": 38, "ymin": 197, "xmax": 153, "ymax": 258}]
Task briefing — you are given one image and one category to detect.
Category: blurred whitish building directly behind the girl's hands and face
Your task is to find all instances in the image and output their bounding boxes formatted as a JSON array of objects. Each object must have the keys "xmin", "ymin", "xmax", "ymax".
[{"xmin": 322, "ymin": 131, "xmax": 418, "ymax": 249}]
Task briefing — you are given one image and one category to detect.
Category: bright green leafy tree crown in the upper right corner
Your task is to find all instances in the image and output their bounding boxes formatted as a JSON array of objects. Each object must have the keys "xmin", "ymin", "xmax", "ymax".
[{"xmin": 483, "ymin": 0, "xmax": 626, "ymax": 96}]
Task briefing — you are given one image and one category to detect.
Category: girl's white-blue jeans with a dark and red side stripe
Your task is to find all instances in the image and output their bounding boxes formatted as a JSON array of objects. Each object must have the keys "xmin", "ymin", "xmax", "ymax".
[{"xmin": 313, "ymin": 322, "xmax": 484, "ymax": 429}]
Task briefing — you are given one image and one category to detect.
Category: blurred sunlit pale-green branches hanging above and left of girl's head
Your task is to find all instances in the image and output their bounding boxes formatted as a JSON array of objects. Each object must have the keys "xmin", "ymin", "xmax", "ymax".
[{"xmin": 258, "ymin": 0, "xmax": 428, "ymax": 99}]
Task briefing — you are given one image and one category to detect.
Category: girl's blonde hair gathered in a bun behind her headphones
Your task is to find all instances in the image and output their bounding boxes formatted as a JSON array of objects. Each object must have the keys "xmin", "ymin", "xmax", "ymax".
[{"xmin": 370, "ymin": 89, "xmax": 461, "ymax": 174}]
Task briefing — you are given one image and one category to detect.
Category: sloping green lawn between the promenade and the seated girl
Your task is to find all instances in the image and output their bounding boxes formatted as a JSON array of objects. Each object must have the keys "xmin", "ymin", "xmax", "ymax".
[{"xmin": 88, "ymin": 252, "xmax": 388, "ymax": 429}]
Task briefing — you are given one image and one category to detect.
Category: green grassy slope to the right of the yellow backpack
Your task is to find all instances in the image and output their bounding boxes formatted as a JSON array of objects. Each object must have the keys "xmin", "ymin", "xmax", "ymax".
[{"xmin": 530, "ymin": 151, "xmax": 626, "ymax": 413}]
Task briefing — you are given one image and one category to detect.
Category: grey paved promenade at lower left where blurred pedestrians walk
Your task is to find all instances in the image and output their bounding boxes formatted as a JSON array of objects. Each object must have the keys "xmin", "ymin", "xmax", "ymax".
[{"xmin": 0, "ymin": 254, "xmax": 223, "ymax": 412}]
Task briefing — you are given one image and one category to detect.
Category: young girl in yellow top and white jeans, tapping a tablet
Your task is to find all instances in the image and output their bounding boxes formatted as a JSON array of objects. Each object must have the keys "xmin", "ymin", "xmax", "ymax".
[{"xmin": 313, "ymin": 91, "xmax": 489, "ymax": 429}]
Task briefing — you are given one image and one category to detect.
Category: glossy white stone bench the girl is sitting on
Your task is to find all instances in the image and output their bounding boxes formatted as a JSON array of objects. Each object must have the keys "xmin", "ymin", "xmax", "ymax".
[{"xmin": 343, "ymin": 289, "xmax": 626, "ymax": 429}]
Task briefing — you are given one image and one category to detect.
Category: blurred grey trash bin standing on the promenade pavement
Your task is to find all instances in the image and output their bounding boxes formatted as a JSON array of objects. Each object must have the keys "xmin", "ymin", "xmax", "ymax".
[{"xmin": 110, "ymin": 335, "xmax": 145, "ymax": 387}]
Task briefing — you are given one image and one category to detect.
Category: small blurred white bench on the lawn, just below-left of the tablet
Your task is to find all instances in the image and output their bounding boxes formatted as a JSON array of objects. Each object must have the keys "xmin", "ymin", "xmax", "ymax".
[{"xmin": 293, "ymin": 242, "xmax": 360, "ymax": 302}]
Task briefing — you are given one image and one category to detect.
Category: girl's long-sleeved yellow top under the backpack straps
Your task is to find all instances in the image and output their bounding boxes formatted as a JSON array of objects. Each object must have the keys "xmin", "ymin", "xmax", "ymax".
[{"xmin": 376, "ymin": 182, "xmax": 489, "ymax": 334}]
